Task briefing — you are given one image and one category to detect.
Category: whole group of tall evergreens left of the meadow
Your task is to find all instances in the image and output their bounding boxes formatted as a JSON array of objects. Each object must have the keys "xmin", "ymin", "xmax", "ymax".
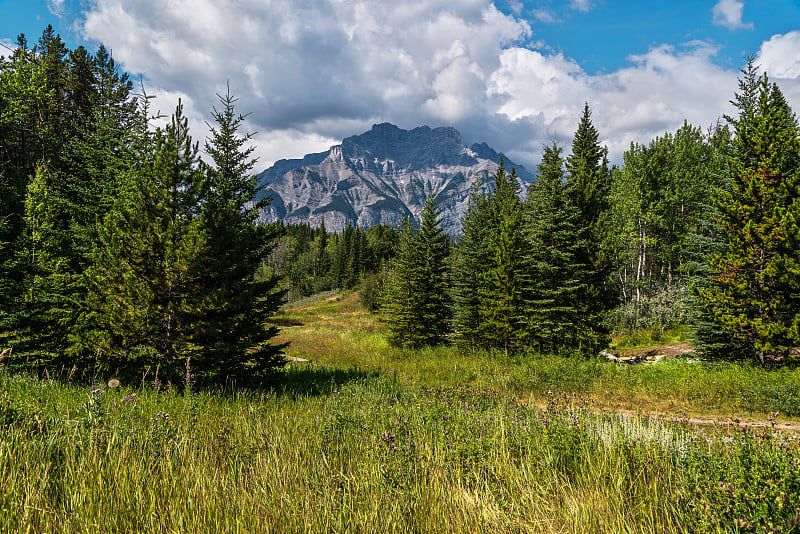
[{"xmin": 0, "ymin": 27, "xmax": 282, "ymax": 382}]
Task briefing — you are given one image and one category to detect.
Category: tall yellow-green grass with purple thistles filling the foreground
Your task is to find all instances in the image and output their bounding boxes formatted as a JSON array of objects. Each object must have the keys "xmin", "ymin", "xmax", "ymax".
[{"xmin": 0, "ymin": 366, "xmax": 800, "ymax": 532}]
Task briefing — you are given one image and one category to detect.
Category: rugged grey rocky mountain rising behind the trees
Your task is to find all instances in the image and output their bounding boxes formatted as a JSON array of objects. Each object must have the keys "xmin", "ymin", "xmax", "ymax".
[{"xmin": 258, "ymin": 123, "xmax": 533, "ymax": 235}]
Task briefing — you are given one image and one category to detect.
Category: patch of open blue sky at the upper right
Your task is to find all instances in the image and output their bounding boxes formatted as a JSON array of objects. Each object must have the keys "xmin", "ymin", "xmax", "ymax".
[{"xmin": 499, "ymin": 0, "xmax": 800, "ymax": 73}]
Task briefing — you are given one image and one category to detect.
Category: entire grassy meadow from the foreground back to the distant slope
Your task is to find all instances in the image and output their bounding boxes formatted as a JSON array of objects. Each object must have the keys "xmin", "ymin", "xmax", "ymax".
[{"xmin": 0, "ymin": 294, "xmax": 800, "ymax": 534}]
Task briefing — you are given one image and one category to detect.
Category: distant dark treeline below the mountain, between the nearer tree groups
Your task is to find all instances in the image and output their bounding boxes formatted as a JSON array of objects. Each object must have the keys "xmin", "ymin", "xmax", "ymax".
[{"xmin": 265, "ymin": 221, "xmax": 400, "ymax": 308}]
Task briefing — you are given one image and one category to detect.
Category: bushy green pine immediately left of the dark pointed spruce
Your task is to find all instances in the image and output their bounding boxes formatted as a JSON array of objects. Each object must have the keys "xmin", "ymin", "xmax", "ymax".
[{"xmin": 88, "ymin": 98, "xmax": 206, "ymax": 379}]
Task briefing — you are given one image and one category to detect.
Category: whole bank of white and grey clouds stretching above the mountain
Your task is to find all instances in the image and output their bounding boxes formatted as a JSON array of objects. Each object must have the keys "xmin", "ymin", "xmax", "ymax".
[{"xmin": 82, "ymin": 0, "xmax": 800, "ymax": 170}]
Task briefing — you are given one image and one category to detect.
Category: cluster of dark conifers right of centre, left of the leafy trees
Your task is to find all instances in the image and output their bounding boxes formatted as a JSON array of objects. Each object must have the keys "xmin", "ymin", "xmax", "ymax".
[{"xmin": 384, "ymin": 105, "xmax": 614, "ymax": 353}]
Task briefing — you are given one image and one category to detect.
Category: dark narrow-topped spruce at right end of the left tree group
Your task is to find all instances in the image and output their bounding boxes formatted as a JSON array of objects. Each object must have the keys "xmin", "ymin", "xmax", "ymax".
[{"xmin": 197, "ymin": 87, "xmax": 284, "ymax": 380}]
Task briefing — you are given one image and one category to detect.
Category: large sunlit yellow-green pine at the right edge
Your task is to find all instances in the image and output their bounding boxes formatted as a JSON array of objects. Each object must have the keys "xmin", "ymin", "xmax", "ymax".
[{"xmin": 701, "ymin": 72, "xmax": 800, "ymax": 364}]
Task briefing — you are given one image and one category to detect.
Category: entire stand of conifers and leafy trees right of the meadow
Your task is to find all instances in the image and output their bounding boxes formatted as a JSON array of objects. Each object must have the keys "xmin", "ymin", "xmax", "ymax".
[{"xmin": 383, "ymin": 60, "xmax": 800, "ymax": 364}]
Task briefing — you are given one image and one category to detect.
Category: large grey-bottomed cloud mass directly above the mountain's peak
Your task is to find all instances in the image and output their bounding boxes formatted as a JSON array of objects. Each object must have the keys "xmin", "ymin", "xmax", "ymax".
[{"xmin": 83, "ymin": 0, "xmax": 530, "ymax": 168}]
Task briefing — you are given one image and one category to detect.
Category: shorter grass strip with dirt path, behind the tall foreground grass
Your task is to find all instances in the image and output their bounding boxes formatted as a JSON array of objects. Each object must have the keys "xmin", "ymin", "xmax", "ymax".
[{"xmin": 272, "ymin": 294, "xmax": 800, "ymax": 422}]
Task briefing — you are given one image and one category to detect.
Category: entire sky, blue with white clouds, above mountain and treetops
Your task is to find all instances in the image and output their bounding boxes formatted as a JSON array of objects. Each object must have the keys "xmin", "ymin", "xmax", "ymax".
[{"xmin": 0, "ymin": 0, "xmax": 800, "ymax": 167}]
